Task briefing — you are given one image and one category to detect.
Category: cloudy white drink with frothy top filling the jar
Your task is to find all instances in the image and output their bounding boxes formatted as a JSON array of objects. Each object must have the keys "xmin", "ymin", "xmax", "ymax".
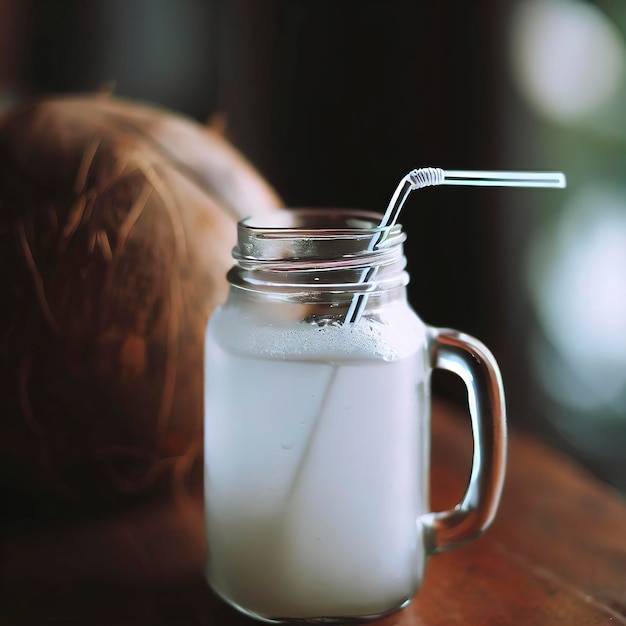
[{"xmin": 205, "ymin": 300, "xmax": 430, "ymax": 618}]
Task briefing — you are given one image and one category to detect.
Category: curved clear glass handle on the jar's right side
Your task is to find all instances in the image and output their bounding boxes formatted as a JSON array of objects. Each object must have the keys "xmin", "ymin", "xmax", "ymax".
[{"xmin": 420, "ymin": 328, "xmax": 506, "ymax": 554}]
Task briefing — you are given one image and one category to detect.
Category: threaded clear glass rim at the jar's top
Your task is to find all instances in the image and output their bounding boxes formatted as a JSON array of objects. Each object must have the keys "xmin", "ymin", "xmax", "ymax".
[{"xmin": 228, "ymin": 208, "xmax": 407, "ymax": 299}]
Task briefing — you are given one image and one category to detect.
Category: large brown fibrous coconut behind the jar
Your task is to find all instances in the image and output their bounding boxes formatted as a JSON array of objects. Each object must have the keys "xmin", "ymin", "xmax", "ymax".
[{"xmin": 0, "ymin": 96, "xmax": 280, "ymax": 520}]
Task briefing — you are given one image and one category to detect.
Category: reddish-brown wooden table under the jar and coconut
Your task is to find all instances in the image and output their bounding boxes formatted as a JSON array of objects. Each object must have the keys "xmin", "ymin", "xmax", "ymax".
[{"xmin": 0, "ymin": 406, "xmax": 626, "ymax": 626}]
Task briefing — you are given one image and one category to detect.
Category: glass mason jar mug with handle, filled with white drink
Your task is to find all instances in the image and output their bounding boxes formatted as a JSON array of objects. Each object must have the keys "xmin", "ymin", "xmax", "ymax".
[{"xmin": 205, "ymin": 209, "xmax": 505, "ymax": 623}]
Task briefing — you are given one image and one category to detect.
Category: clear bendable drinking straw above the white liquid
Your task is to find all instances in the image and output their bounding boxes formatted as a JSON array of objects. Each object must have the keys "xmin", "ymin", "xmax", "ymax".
[{"xmin": 344, "ymin": 167, "xmax": 567, "ymax": 325}]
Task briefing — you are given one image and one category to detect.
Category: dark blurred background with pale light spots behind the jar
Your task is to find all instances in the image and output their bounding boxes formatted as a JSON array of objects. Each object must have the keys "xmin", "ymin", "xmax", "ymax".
[{"xmin": 0, "ymin": 0, "xmax": 626, "ymax": 491}]
